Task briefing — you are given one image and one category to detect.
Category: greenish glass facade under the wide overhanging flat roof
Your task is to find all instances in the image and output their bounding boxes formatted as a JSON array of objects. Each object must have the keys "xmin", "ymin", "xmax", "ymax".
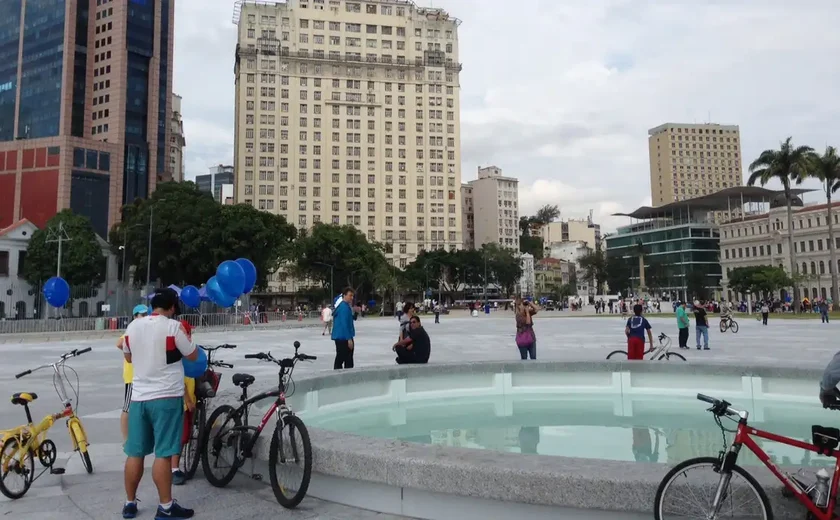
[{"xmin": 607, "ymin": 222, "xmax": 721, "ymax": 297}]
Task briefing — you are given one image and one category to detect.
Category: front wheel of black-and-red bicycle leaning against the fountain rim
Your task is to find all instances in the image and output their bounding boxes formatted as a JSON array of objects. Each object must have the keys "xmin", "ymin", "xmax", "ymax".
[{"xmin": 268, "ymin": 415, "xmax": 312, "ymax": 509}]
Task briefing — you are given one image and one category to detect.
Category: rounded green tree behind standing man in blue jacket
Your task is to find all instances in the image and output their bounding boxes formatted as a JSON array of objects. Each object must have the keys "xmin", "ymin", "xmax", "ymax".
[{"xmin": 294, "ymin": 223, "xmax": 389, "ymax": 297}]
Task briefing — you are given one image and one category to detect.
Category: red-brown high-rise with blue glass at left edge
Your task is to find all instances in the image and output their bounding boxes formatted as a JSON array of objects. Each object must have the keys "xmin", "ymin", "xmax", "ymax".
[{"xmin": 0, "ymin": 0, "xmax": 174, "ymax": 237}]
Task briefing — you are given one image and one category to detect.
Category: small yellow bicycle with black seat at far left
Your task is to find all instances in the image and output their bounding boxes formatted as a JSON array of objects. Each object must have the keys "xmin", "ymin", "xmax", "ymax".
[{"xmin": 0, "ymin": 347, "xmax": 93, "ymax": 499}]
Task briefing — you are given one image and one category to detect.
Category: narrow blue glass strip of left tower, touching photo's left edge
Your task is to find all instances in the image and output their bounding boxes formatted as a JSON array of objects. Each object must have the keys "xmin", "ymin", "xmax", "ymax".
[{"xmin": 0, "ymin": 0, "xmax": 21, "ymax": 141}]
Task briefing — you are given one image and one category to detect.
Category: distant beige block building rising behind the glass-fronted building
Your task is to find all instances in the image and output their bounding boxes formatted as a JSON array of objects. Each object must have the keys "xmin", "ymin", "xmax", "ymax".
[{"xmin": 648, "ymin": 123, "xmax": 744, "ymax": 206}]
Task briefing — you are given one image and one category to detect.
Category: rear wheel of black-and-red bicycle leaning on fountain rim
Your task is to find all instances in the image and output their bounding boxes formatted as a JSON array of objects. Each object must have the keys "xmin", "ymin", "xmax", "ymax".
[{"xmin": 200, "ymin": 405, "xmax": 242, "ymax": 487}]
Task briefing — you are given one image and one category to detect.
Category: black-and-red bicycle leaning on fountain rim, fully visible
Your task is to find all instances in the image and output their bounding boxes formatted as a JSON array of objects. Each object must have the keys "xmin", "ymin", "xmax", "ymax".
[{"xmin": 201, "ymin": 341, "xmax": 318, "ymax": 509}]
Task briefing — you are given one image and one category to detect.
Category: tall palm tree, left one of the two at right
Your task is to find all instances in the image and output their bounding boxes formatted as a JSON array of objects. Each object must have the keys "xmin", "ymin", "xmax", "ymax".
[{"xmin": 747, "ymin": 137, "xmax": 814, "ymax": 312}]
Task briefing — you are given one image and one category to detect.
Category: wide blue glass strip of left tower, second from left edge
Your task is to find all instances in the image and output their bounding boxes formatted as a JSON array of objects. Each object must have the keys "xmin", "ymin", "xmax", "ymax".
[{"xmin": 18, "ymin": 0, "xmax": 65, "ymax": 139}]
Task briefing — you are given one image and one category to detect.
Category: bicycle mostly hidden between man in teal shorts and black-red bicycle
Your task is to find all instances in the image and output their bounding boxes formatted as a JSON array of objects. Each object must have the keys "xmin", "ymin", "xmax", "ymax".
[{"xmin": 180, "ymin": 344, "xmax": 236, "ymax": 479}]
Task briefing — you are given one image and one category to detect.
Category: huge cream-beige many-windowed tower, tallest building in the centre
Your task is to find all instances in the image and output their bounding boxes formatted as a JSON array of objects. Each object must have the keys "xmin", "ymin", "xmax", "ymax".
[{"xmin": 234, "ymin": 0, "xmax": 463, "ymax": 266}]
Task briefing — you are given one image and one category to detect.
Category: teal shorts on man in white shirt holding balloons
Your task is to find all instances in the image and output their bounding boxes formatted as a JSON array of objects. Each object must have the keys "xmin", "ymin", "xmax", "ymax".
[{"xmin": 124, "ymin": 397, "xmax": 184, "ymax": 459}]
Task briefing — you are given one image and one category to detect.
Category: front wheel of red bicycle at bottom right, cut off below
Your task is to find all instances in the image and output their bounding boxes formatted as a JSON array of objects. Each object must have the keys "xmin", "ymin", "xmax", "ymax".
[{"xmin": 653, "ymin": 457, "xmax": 773, "ymax": 520}]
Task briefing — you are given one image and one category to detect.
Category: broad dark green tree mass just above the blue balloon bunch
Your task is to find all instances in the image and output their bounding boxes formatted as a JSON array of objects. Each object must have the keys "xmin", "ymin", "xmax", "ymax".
[{"xmin": 110, "ymin": 182, "xmax": 297, "ymax": 288}]
